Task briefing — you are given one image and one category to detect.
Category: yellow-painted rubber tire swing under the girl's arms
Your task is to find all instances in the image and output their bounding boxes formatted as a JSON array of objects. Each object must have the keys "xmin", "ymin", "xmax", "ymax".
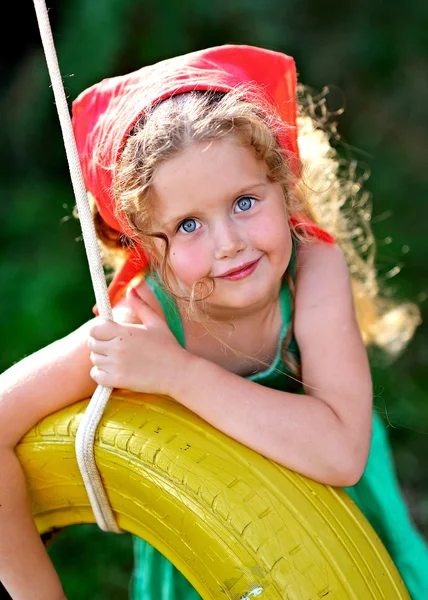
[{"xmin": 17, "ymin": 391, "xmax": 409, "ymax": 600}]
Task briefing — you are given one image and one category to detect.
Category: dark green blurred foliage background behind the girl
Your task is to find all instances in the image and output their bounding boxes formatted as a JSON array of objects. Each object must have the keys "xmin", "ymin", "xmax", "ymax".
[{"xmin": 0, "ymin": 0, "xmax": 428, "ymax": 600}]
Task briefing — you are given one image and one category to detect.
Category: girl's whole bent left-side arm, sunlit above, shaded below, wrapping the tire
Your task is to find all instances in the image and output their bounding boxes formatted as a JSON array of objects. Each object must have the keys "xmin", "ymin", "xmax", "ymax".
[{"xmin": 0, "ymin": 324, "xmax": 96, "ymax": 600}]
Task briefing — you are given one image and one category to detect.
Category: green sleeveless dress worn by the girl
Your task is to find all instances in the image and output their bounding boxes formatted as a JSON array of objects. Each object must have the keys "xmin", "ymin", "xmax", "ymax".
[{"xmin": 131, "ymin": 260, "xmax": 428, "ymax": 600}]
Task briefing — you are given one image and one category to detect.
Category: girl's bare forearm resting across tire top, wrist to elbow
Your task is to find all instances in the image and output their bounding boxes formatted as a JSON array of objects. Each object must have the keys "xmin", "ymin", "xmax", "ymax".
[{"xmin": 172, "ymin": 357, "xmax": 366, "ymax": 486}]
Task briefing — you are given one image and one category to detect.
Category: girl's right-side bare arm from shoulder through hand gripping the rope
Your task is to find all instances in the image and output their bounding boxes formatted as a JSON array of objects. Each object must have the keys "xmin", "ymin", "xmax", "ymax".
[{"xmin": 91, "ymin": 243, "xmax": 372, "ymax": 486}]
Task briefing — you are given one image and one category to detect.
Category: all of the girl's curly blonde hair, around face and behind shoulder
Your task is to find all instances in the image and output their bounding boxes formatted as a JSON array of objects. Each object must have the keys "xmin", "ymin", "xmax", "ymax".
[{"xmin": 90, "ymin": 86, "xmax": 419, "ymax": 375}]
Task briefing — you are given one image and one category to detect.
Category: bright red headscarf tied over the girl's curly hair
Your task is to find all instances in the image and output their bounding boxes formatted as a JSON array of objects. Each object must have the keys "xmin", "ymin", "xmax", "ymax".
[{"xmin": 72, "ymin": 45, "xmax": 334, "ymax": 304}]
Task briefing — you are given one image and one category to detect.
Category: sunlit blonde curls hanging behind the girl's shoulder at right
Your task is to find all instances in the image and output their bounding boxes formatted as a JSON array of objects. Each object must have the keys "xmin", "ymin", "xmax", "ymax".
[{"xmin": 298, "ymin": 86, "xmax": 421, "ymax": 359}]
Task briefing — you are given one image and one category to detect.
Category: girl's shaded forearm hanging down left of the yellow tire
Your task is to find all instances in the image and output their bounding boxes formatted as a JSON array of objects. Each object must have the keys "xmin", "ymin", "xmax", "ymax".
[{"xmin": 0, "ymin": 448, "xmax": 66, "ymax": 600}]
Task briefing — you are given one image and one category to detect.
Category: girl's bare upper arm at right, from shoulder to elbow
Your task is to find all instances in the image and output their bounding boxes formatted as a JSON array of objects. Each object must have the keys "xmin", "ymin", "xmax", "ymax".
[{"xmin": 294, "ymin": 242, "xmax": 372, "ymax": 422}]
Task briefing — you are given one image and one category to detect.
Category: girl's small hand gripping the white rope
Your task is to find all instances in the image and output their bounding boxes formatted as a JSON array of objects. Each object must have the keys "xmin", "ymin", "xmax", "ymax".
[{"xmin": 88, "ymin": 291, "xmax": 189, "ymax": 396}]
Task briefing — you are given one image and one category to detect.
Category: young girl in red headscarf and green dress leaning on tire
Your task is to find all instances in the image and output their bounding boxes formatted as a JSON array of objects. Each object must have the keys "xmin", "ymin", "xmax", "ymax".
[{"xmin": 0, "ymin": 46, "xmax": 428, "ymax": 600}]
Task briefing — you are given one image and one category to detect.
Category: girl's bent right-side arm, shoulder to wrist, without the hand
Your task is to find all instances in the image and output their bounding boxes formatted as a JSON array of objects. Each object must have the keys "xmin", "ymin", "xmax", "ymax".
[{"xmin": 173, "ymin": 244, "xmax": 372, "ymax": 486}]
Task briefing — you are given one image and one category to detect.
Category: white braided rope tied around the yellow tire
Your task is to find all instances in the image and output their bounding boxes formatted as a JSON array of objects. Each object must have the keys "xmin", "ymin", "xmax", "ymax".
[{"xmin": 33, "ymin": 0, "xmax": 122, "ymax": 533}]
